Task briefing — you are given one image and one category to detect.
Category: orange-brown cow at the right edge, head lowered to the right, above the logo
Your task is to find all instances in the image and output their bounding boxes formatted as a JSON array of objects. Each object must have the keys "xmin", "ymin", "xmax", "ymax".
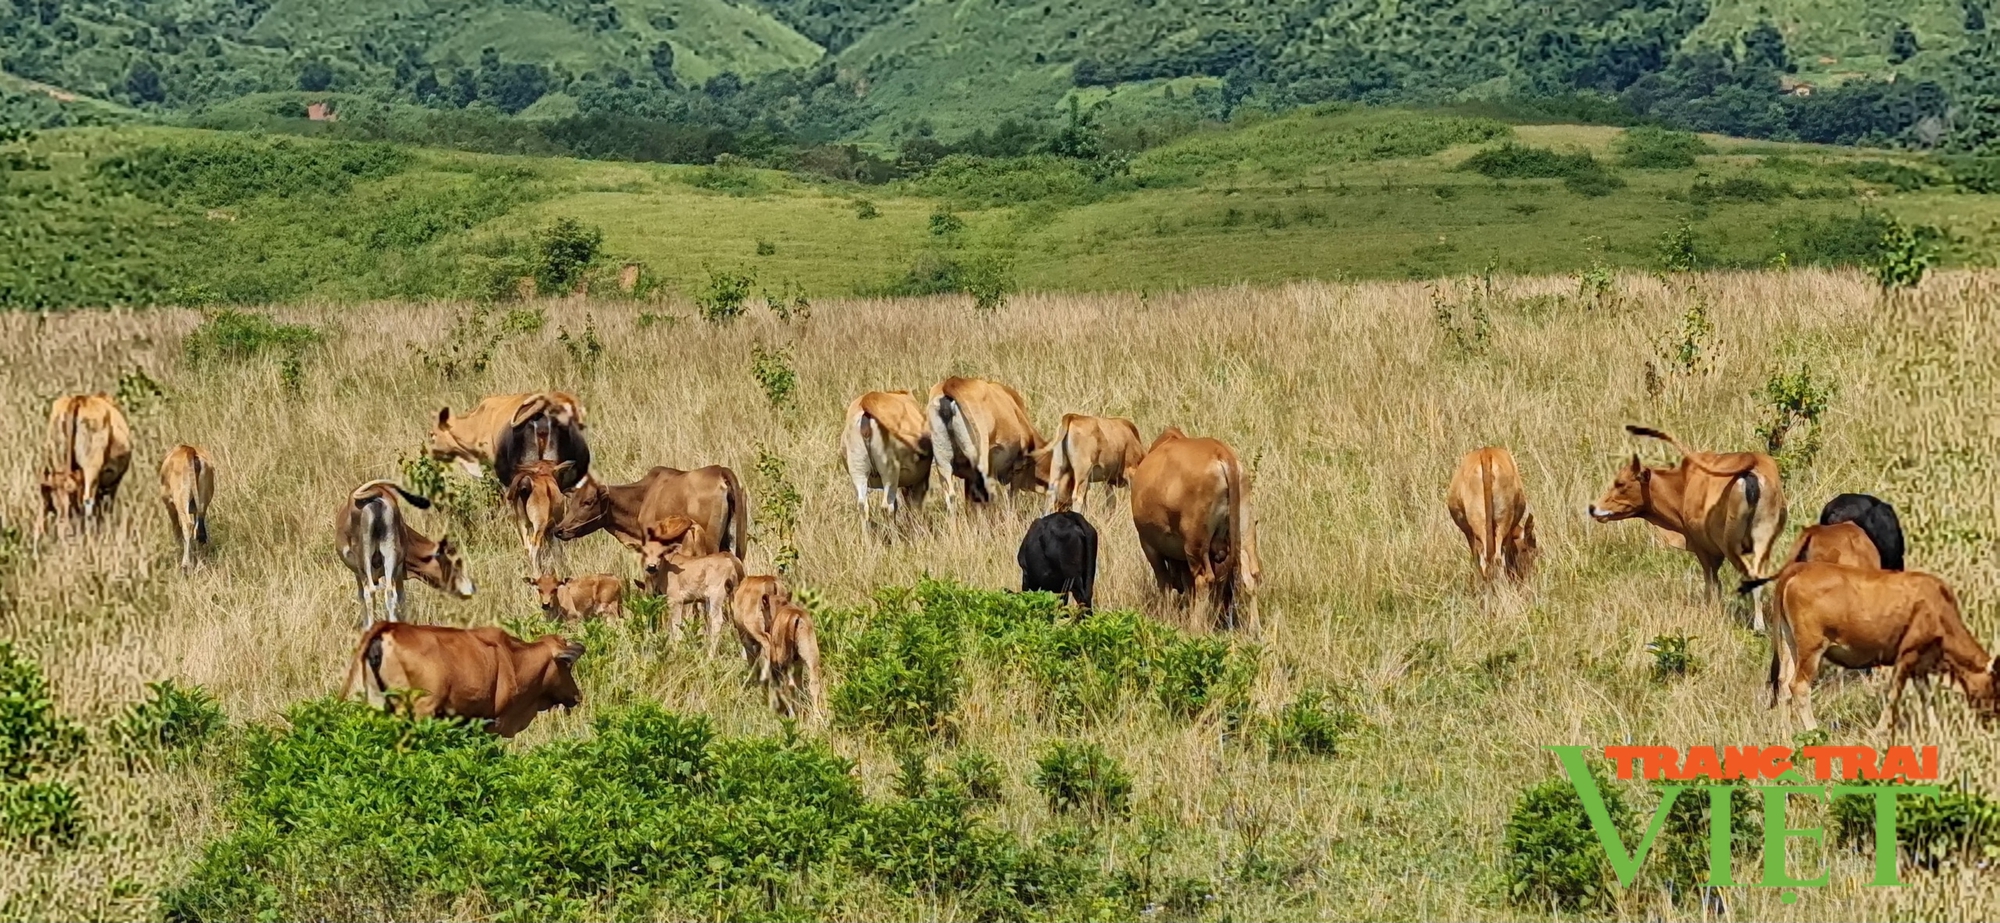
[{"xmin": 1770, "ymin": 561, "xmax": 2000, "ymax": 735}]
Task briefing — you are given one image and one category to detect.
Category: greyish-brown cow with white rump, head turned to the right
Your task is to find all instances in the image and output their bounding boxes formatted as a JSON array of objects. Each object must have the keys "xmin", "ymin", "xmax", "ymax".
[{"xmin": 334, "ymin": 481, "xmax": 472, "ymax": 627}]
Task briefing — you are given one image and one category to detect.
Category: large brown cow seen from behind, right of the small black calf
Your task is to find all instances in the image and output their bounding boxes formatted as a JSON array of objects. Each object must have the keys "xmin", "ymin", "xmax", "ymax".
[{"xmin": 1132, "ymin": 428, "xmax": 1264, "ymax": 633}]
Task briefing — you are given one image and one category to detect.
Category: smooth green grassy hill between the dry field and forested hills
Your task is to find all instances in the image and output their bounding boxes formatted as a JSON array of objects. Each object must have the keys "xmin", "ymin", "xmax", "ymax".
[{"xmin": 0, "ymin": 108, "xmax": 2000, "ymax": 306}]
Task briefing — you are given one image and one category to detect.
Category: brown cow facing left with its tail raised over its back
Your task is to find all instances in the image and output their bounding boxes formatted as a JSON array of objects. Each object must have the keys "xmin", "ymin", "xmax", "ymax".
[{"xmin": 1590, "ymin": 426, "xmax": 1784, "ymax": 631}]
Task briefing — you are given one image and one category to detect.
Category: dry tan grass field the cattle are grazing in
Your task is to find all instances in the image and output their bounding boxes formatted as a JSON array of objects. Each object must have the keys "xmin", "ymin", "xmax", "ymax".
[{"xmin": 0, "ymin": 272, "xmax": 2000, "ymax": 919}]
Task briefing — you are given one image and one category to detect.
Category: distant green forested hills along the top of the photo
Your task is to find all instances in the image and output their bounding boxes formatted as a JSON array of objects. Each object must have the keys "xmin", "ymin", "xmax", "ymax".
[{"xmin": 0, "ymin": 0, "xmax": 2000, "ymax": 150}]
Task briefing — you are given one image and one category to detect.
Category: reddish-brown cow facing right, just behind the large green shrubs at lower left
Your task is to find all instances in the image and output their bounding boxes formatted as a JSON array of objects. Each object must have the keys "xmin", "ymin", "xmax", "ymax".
[{"xmin": 340, "ymin": 621, "xmax": 584, "ymax": 737}]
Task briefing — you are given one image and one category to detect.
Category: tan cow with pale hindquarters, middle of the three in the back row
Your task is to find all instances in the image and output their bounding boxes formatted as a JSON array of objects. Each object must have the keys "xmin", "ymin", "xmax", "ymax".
[{"xmin": 926, "ymin": 378, "xmax": 1048, "ymax": 511}]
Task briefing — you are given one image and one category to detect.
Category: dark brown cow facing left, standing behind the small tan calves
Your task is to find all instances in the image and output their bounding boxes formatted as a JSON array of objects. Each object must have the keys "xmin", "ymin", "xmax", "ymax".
[{"xmin": 556, "ymin": 465, "xmax": 750, "ymax": 557}]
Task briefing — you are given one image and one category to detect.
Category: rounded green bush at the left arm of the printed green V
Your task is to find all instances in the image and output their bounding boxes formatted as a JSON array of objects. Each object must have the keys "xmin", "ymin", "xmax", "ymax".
[{"xmin": 1504, "ymin": 765, "xmax": 1632, "ymax": 913}]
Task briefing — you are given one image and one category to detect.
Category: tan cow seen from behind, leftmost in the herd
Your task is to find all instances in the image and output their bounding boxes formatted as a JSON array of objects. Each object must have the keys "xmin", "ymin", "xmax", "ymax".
[{"xmin": 36, "ymin": 392, "xmax": 132, "ymax": 535}]
